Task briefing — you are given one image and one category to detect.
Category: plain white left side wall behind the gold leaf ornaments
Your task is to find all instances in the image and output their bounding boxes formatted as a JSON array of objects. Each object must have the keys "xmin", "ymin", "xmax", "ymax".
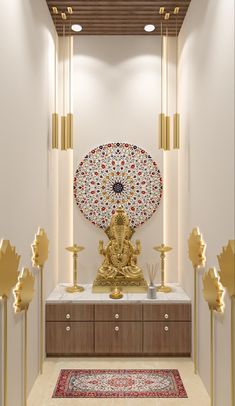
[{"xmin": 0, "ymin": 0, "xmax": 57, "ymax": 406}]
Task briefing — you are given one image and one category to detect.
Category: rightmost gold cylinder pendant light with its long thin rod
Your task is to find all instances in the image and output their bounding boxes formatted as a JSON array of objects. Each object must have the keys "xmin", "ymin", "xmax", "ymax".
[{"xmin": 173, "ymin": 7, "xmax": 180, "ymax": 149}]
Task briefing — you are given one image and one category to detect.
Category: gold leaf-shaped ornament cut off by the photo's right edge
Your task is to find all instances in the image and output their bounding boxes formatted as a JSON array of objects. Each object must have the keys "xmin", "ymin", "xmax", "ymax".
[{"xmin": 217, "ymin": 240, "xmax": 235, "ymax": 297}]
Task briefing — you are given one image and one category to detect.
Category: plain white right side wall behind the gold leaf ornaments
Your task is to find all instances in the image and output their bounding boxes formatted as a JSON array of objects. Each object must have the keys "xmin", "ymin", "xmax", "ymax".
[{"xmin": 179, "ymin": 0, "xmax": 235, "ymax": 406}]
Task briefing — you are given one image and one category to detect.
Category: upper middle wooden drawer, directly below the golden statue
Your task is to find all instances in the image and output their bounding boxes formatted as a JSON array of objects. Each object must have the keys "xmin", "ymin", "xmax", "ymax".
[{"xmin": 95, "ymin": 304, "xmax": 142, "ymax": 321}]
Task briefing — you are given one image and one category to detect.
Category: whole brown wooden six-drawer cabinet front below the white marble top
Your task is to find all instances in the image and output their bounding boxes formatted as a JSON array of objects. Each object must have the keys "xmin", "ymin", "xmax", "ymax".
[{"xmin": 46, "ymin": 303, "xmax": 191, "ymax": 356}]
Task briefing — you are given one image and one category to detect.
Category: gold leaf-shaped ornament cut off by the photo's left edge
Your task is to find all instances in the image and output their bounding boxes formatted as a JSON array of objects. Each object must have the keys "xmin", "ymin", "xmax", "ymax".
[{"xmin": 0, "ymin": 240, "xmax": 20, "ymax": 297}]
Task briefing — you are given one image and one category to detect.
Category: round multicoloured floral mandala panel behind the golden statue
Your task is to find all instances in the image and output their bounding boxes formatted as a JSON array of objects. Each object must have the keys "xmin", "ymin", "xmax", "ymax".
[{"xmin": 74, "ymin": 143, "xmax": 162, "ymax": 229}]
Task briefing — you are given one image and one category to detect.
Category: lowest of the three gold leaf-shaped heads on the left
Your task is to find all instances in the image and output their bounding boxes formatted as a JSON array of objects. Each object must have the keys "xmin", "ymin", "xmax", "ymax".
[{"xmin": 14, "ymin": 268, "xmax": 35, "ymax": 313}]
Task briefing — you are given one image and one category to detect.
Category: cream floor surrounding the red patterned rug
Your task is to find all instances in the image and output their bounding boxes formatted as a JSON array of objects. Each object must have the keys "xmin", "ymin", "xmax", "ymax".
[{"xmin": 28, "ymin": 357, "xmax": 210, "ymax": 406}]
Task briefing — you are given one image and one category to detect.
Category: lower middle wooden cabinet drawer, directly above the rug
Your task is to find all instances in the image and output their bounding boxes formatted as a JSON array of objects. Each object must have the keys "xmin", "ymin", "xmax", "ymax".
[{"xmin": 95, "ymin": 322, "xmax": 142, "ymax": 354}]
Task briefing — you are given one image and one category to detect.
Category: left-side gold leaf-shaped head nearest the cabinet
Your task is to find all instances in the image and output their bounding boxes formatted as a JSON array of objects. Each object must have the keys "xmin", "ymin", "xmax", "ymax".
[{"xmin": 31, "ymin": 228, "xmax": 49, "ymax": 268}]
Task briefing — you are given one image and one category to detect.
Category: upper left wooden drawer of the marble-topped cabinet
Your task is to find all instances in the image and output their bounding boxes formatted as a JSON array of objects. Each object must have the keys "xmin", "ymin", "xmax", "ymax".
[{"xmin": 46, "ymin": 303, "xmax": 94, "ymax": 321}]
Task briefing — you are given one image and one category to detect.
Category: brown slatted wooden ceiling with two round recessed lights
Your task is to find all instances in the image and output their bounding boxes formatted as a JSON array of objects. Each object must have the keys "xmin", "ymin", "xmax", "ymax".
[{"xmin": 46, "ymin": 0, "xmax": 191, "ymax": 36}]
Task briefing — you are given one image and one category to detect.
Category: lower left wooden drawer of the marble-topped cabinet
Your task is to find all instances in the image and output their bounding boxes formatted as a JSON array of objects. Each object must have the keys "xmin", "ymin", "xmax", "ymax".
[{"xmin": 46, "ymin": 321, "xmax": 94, "ymax": 355}]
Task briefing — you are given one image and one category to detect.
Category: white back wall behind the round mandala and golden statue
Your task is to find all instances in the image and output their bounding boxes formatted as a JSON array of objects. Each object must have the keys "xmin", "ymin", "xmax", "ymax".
[{"xmin": 64, "ymin": 36, "xmax": 178, "ymax": 283}]
